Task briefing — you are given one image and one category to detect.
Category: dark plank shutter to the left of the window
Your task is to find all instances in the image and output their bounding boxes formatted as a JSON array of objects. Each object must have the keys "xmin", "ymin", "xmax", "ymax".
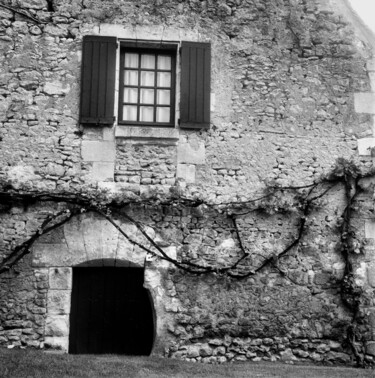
[{"xmin": 80, "ymin": 36, "xmax": 117, "ymax": 125}]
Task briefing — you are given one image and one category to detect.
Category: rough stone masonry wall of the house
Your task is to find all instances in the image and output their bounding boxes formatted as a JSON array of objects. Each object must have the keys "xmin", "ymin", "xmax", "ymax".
[{"xmin": 0, "ymin": 0, "xmax": 375, "ymax": 364}]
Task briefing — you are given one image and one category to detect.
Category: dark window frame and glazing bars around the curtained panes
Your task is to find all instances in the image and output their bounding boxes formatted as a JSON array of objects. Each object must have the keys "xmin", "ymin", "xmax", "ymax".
[{"xmin": 117, "ymin": 41, "xmax": 178, "ymax": 127}]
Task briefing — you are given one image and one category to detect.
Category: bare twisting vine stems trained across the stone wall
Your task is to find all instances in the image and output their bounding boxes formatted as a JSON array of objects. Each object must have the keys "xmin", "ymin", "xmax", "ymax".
[{"xmin": 0, "ymin": 159, "xmax": 375, "ymax": 366}]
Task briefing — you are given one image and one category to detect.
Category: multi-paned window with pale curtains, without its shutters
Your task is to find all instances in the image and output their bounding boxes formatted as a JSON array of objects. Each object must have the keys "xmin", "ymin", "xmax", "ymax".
[{"xmin": 119, "ymin": 47, "xmax": 176, "ymax": 126}]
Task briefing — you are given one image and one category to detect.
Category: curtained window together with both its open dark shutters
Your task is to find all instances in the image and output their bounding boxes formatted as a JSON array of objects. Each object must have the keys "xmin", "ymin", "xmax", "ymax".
[{"xmin": 80, "ymin": 36, "xmax": 211, "ymax": 128}]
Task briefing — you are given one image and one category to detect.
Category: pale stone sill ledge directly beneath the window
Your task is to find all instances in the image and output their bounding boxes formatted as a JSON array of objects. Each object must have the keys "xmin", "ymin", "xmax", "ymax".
[{"xmin": 115, "ymin": 126, "xmax": 179, "ymax": 141}]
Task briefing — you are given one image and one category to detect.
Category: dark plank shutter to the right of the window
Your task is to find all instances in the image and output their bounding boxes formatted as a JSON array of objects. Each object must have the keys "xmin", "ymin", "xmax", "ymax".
[{"xmin": 180, "ymin": 42, "xmax": 211, "ymax": 128}]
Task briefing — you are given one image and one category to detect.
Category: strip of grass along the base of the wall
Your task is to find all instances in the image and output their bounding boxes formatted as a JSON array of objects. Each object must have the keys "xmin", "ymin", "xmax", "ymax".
[{"xmin": 0, "ymin": 349, "xmax": 374, "ymax": 378}]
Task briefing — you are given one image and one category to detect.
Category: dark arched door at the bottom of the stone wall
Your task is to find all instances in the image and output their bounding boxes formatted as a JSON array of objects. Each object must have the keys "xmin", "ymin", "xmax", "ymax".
[{"xmin": 69, "ymin": 267, "xmax": 154, "ymax": 355}]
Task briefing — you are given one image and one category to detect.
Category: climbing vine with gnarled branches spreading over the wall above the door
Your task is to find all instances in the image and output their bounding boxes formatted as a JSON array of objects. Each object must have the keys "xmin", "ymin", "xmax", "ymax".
[{"xmin": 0, "ymin": 159, "xmax": 374, "ymax": 365}]
